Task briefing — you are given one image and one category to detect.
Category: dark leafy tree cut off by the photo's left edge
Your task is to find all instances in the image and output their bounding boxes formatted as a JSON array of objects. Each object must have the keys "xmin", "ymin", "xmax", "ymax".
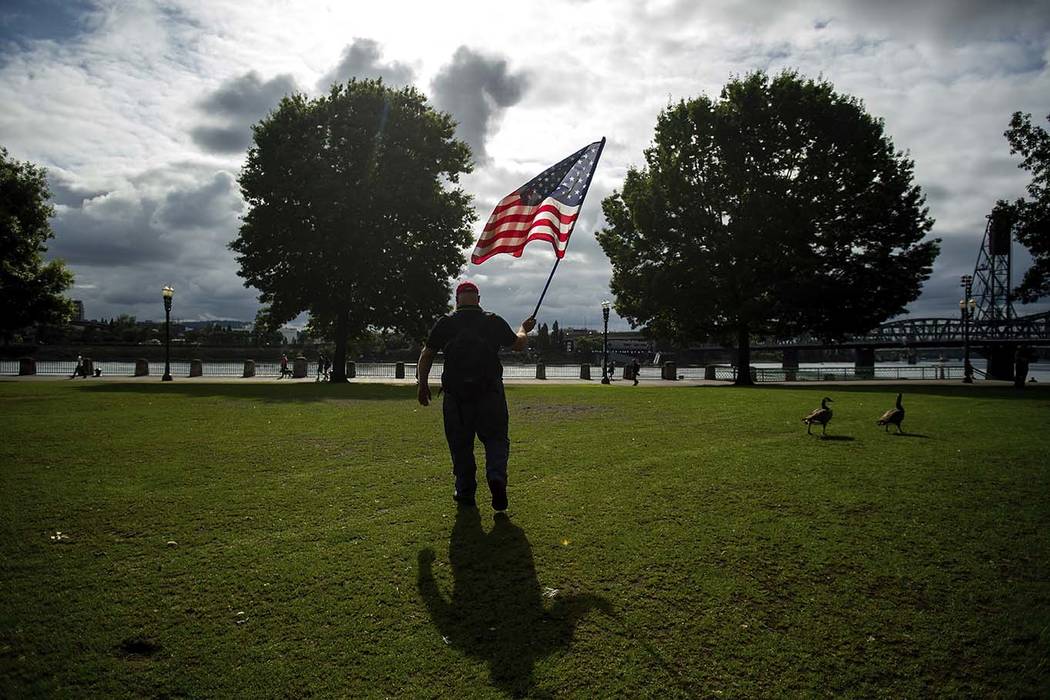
[{"xmin": 0, "ymin": 147, "xmax": 72, "ymax": 342}]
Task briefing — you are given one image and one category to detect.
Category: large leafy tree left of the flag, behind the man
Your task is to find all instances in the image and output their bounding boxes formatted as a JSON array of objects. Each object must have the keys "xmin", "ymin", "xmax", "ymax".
[{"xmin": 230, "ymin": 81, "xmax": 476, "ymax": 381}]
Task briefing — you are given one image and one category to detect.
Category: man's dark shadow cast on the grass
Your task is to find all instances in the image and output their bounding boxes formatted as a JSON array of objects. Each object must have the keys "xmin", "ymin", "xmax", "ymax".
[{"xmin": 418, "ymin": 508, "xmax": 612, "ymax": 697}]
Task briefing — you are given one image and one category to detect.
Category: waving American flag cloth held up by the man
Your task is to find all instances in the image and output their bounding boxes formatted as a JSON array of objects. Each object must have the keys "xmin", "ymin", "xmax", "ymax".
[{"xmin": 470, "ymin": 139, "xmax": 605, "ymax": 264}]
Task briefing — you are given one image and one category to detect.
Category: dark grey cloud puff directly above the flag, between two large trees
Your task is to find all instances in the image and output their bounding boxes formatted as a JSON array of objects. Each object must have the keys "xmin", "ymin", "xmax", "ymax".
[{"xmin": 431, "ymin": 46, "xmax": 528, "ymax": 163}]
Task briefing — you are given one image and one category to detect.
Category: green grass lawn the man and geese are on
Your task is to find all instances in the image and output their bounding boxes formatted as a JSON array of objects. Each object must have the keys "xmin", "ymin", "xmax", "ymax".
[{"xmin": 0, "ymin": 382, "xmax": 1050, "ymax": 698}]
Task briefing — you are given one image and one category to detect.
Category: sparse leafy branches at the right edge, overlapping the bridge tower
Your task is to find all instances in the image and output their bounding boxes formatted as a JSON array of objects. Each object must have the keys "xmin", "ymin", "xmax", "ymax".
[{"xmin": 996, "ymin": 112, "xmax": 1050, "ymax": 303}]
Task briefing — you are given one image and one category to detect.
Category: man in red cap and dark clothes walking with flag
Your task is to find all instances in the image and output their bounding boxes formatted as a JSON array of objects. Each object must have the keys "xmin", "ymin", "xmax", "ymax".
[{"xmin": 416, "ymin": 282, "xmax": 536, "ymax": 511}]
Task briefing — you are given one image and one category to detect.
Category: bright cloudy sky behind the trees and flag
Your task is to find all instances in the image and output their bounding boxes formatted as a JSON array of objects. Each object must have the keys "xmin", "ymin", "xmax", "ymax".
[{"xmin": 0, "ymin": 0, "xmax": 1050, "ymax": 327}]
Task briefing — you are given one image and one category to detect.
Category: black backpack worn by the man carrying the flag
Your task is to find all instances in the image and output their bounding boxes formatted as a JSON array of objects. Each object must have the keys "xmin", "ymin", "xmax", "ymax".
[{"xmin": 441, "ymin": 312, "xmax": 499, "ymax": 401}]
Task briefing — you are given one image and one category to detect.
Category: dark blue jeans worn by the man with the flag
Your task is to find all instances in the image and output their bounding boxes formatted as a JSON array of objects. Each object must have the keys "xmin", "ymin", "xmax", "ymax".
[{"xmin": 442, "ymin": 382, "xmax": 510, "ymax": 497}]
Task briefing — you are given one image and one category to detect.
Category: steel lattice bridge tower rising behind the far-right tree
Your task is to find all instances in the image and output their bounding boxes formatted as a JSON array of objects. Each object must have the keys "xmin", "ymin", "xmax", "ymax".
[{"xmin": 973, "ymin": 200, "xmax": 1016, "ymax": 337}]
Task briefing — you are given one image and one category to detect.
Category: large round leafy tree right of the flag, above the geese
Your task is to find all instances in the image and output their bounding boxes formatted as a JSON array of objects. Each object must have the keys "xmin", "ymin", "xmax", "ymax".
[{"xmin": 597, "ymin": 71, "xmax": 939, "ymax": 384}]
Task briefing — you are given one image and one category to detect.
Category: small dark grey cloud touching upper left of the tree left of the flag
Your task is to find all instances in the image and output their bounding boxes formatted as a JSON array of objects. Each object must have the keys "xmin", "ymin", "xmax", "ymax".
[{"xmin": 190, "ymin": 70, "xmax": 298, "ymax": 153}]
